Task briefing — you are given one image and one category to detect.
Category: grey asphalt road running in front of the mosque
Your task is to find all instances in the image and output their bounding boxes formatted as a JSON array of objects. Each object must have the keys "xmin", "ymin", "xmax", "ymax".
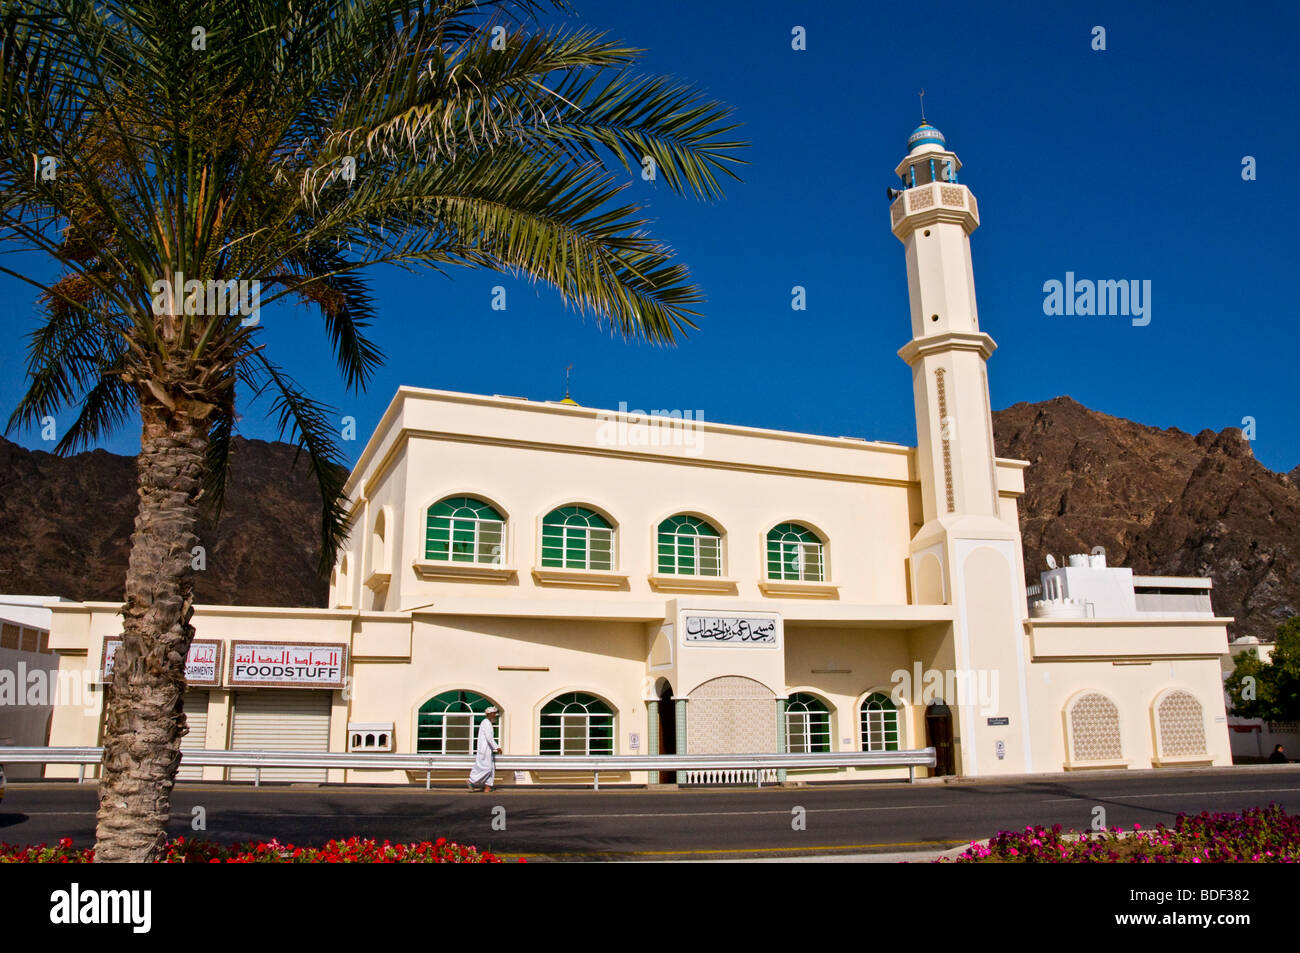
[{"xmin": 0, "ymin": 766, "xmax": 1300, "ymax": 859}]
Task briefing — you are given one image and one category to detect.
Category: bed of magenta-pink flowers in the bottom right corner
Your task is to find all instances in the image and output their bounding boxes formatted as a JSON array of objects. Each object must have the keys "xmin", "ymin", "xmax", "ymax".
[{"xmin": 944, "ymin": 803, "xmax": 1300, "ymax": 863}]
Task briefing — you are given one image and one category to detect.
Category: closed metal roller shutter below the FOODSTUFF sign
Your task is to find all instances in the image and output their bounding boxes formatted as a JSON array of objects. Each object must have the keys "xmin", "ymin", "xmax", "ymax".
[{"xmin": 230, "ymin": 688, "xmax": 332, "ymax": 781}]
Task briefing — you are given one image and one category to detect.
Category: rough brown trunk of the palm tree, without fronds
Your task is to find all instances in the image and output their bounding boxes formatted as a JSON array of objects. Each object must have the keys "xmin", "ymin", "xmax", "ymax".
[{"xmin": 95, "ymin": 394, "xmax": 208, "ymax": 863}]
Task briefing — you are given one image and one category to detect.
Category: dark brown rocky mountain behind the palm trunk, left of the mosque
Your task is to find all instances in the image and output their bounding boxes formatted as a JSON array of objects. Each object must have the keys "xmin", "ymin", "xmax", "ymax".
[{"xmin": 0, "ymin": 438, "xmax": 329, "ymax": 606}]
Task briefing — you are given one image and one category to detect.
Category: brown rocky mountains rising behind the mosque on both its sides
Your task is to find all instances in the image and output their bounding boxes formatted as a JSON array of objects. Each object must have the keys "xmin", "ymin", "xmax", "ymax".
[{"xmin": 0, "ymin": 397, "xmax": 1300, "ymax": 638}]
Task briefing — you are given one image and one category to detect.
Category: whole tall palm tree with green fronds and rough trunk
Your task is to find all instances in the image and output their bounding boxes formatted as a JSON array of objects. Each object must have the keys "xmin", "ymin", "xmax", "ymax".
[{"xmin": 0, "ymin": 0, "xmax": 744, "ymax": 862}]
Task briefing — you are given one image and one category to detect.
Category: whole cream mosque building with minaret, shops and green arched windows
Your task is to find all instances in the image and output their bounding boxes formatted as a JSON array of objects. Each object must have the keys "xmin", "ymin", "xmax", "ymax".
[{"xmin": 47, "ymin": 124, "xmax": 1231, "ymax": 784}]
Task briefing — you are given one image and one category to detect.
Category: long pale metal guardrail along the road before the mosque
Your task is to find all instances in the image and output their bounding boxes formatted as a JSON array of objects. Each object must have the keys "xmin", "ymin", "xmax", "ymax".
[{"xmin": 0, "ymin": 748, "xmax": 935, "ymax": 789}]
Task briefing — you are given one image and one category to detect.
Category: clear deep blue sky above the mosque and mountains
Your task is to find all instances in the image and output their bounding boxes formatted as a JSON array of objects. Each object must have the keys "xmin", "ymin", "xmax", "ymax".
[{"xmin": 0, "ymin": 0, "xmax": 1300, "ymax": 471}]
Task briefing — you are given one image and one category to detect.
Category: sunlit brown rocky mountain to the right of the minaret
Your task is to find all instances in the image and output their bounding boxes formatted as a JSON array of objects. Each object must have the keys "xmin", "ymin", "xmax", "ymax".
[{"xmin": 993, "ymin": 397, "xmax": 1300, "ymax": 638}]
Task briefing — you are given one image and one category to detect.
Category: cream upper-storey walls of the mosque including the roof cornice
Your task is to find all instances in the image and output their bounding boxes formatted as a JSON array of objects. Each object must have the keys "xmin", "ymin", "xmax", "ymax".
[{"xmin": 332, "ymin": 389, "xmax": 919, "ymax": 610}]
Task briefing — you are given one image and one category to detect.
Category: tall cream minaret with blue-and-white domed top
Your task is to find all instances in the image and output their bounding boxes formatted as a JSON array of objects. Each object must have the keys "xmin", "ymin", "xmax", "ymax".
[{"xmin": 889, "ymin": 120, "xmax": 1032, "ymax": 775}]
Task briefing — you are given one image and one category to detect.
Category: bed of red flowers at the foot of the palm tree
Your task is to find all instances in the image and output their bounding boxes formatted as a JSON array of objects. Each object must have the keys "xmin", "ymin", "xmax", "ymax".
[{"xmin": 0, "ymin": 837, "xmax": 523, "ymax": 863}]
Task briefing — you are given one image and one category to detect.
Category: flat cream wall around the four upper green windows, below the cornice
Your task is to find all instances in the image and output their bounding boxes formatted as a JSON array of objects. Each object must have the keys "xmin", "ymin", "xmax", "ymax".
[{"xmin": 400, "ymin": 431, "xmax": 907, "ymax": 607}]
